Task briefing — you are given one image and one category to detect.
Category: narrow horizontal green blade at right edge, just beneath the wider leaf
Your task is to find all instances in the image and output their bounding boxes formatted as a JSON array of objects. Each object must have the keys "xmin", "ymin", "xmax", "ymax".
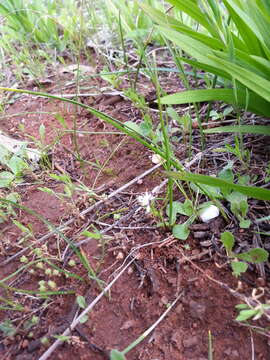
[{"xmin": 204, "ymin": 124, "xmax": 270, "ymax": 136}]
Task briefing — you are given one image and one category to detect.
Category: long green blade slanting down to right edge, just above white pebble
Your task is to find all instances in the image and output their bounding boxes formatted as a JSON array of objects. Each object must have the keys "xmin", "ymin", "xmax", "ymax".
[{"xmin": 167, "ymin": 171, "xmax": 270, "ymax": 201}]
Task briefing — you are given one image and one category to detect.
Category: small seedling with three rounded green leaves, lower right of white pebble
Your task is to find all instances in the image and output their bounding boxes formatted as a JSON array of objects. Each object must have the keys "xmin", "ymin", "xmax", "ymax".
[{"xmin": 221, "ymin": 231, "xmax": 269, "ymax": 277}]
